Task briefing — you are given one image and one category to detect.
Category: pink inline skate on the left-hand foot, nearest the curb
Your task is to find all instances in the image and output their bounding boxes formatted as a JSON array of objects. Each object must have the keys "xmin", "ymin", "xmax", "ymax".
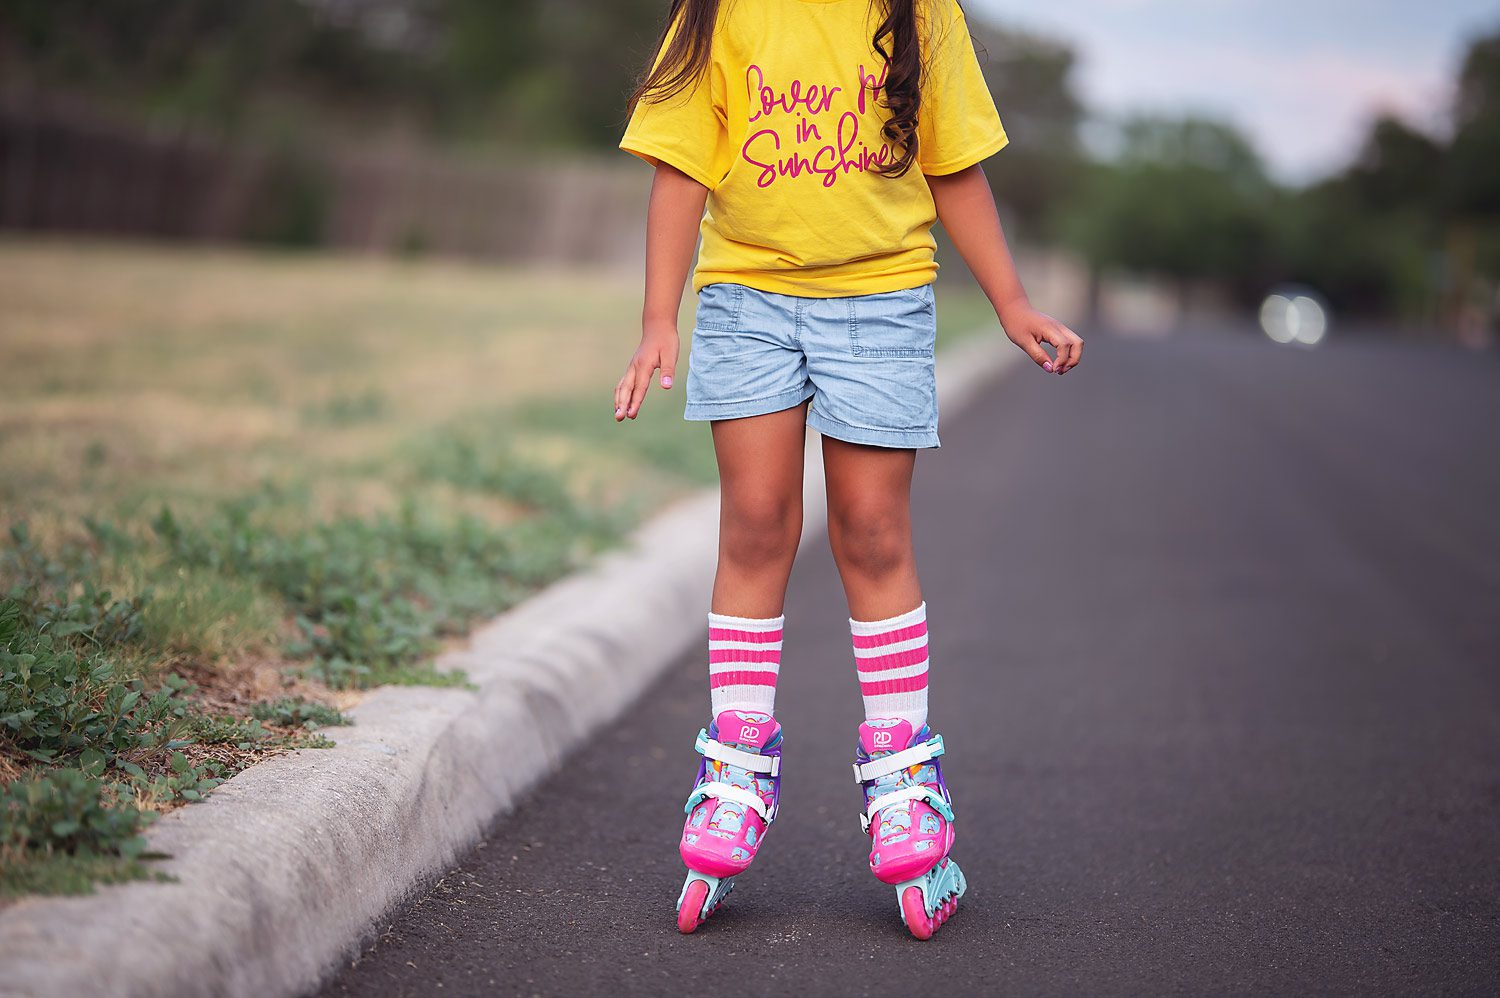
[{"xmin": 677, "ymin": 710, "xmax": 782, "ymax": 932}]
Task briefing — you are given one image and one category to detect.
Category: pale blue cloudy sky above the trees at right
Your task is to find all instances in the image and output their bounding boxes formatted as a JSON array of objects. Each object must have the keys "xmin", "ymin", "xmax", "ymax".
[{"xmin": 965, "ymin": 0, "xmax": 1500, "ymax": 182}]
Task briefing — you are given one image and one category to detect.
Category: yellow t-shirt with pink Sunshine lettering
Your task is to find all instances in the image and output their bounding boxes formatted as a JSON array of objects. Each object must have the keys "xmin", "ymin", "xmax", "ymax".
[{"xmin": 620, "ymin": 0, "xmax": 1007, "ymax": 297}]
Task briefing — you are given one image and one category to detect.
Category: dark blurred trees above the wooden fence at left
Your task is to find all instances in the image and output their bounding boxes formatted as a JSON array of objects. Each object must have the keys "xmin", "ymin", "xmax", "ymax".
[{"xmin": 0, "ymin": 0, "xmax": 668, "ymax": 147}]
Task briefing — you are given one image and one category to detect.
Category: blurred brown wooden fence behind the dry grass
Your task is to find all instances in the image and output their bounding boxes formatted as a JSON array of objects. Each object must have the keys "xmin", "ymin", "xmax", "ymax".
[{"xmin": 0, "ymin": 101, "xmax": 650, "ymax": 263}]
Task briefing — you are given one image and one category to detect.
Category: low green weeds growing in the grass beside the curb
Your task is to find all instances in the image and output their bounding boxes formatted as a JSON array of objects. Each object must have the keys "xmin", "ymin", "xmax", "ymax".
[{"xmin": 0, "ymin": 429, "xmax": 632, "ymax": 896}]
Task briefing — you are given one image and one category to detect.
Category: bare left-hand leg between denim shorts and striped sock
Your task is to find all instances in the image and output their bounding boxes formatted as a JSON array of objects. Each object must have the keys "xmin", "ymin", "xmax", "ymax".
[{"xmin": 711, "ymin": 402, "xmax": 807, "ymax": 618}]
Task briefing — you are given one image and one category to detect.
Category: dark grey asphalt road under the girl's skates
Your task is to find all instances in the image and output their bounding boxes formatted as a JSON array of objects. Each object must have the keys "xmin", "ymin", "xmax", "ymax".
[{"xmin": 324, "ymin": 335, "xmax": 1500, "ymax": 995}]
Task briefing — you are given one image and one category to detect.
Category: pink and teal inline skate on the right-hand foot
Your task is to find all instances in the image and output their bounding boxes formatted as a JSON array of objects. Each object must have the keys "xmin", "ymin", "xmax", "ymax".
[{"xmin": 854, "ymin": 717, "xmax": 968, "ymax": 939}]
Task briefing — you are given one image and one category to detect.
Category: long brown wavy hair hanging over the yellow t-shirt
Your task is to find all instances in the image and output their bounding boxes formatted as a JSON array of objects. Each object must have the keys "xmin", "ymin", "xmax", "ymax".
[{"xmin": 627, "ymin": 0, "xmax": 924, "ymax": 177}]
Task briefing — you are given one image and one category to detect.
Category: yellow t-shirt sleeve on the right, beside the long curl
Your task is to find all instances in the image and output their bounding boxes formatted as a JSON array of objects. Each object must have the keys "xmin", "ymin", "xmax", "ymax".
[{"xmin": 917, "ymin": 0, "xmax": 1010, "ymax": 176}]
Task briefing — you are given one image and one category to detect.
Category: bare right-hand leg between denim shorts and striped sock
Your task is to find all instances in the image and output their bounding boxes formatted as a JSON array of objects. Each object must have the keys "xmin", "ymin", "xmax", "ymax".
[{"xmin": 824, "ymin": 437, "xmax": 923, "ymax": 620}]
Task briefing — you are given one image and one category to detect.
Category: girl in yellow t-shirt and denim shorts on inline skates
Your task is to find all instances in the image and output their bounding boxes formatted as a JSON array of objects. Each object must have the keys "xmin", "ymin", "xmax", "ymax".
[{"xmin": 615, "ymin": 0, "xmax": 1083, "ymax": 939}]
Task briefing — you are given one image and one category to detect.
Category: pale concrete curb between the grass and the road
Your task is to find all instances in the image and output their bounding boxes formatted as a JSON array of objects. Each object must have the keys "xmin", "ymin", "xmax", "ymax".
[{"xmin": 0, "ymin": 336, "xmax": 1020, "ymax": 998}]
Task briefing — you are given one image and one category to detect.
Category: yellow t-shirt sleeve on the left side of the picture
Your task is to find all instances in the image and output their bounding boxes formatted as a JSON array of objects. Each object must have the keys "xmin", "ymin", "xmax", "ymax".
[{"xmin": 620, "ymin": 12, "xmax": 735, "ymax": 191}]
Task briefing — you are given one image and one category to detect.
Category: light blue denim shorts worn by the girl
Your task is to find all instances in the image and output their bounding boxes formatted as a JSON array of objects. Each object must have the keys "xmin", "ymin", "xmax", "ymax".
[{"xmin": 684, "ymin": 284, "xmax": 939, "ymax": 447}]
